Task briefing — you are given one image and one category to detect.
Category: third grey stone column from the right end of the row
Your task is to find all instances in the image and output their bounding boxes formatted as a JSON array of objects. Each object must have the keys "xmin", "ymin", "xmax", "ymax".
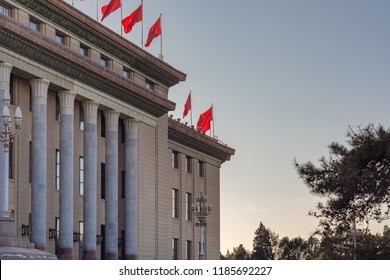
[{"xmin": 83, "ymin": 101, "xmax": 99, "ymax": 260}]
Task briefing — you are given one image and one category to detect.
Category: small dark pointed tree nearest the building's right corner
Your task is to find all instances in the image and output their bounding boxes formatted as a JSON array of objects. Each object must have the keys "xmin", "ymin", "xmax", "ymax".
[{"xmin": 251, "ymin": 222, "xmax": 278, "ymax": 260}]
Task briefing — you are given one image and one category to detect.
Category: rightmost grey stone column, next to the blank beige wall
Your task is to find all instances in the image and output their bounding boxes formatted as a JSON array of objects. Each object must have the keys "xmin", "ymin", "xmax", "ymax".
[{"xmin": 124, "ymin": 119, "xmax": 138, "ymax": 260}]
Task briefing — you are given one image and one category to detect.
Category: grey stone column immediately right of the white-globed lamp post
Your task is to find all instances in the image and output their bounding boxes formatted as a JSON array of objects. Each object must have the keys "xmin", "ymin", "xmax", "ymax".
[{"xmin": 30, "ymin": 79, "xmax": 50, "ymax": 251}]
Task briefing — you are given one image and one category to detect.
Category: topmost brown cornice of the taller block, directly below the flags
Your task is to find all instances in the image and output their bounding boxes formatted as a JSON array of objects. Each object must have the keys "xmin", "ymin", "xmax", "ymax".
[{"xmin": 14, "ymin": 0, "xmax": 186, "ymax": 87}]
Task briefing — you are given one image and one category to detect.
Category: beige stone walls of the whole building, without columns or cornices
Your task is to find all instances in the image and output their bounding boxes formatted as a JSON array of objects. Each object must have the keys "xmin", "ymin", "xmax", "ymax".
[{"xmin": 0, "ymin": 1, "xmax": 229, "ymax": 259}]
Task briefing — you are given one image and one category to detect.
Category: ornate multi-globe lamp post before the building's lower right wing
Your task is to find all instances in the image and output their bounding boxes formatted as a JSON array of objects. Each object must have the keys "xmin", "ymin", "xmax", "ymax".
[{"xmin": 191, "ymin": 192, "xmax": 211, "ymax": 260}]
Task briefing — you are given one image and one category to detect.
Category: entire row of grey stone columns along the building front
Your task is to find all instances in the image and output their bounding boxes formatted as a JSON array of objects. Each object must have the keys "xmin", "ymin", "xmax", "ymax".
[{"xmin": 0, "ymin": 63, "xmax": 138, "ymax": 259}]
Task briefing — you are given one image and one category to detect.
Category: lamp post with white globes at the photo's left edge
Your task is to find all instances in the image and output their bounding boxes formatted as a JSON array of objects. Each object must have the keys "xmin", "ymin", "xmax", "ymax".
[{"xmin": 0, "ymin": 91, "xmax": 22, "ymax": 217}]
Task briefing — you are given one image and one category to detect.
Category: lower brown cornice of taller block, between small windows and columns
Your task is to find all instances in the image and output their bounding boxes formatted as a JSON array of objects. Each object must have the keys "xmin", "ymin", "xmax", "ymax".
[{"xmin": 0, "ymin": 13, "xmax": 175, "ymax": 117}]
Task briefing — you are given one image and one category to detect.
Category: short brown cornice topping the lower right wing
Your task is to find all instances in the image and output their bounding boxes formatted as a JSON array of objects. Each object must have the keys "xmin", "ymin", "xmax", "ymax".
[{"xmin": 168, "ymin": 119, "xmax": 235, "ymax": 162}]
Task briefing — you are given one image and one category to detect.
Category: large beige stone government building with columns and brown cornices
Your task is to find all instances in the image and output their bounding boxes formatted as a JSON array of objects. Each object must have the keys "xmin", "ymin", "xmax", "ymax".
[{"xmin": 0, "ymin": 0, "xmax": 235, "ymax": 260}]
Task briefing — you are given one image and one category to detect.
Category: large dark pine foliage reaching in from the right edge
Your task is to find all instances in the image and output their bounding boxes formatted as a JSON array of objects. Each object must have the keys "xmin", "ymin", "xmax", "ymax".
[{"xmin": 295, "ymin": 125, "xmax": 390, "ymax": 233}]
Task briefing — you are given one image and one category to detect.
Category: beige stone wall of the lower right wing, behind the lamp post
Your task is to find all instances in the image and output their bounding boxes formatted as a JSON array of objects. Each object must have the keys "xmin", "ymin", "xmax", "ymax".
[{"xmin": 169, "ymin": 141, "xmax": 221, "ymax": 259}]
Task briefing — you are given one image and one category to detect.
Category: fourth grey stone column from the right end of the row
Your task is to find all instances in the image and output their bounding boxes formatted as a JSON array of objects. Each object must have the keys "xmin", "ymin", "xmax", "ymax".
[{"xmin": 58, "ymin": 90, "xmax": 76, "ymax": 260}]
